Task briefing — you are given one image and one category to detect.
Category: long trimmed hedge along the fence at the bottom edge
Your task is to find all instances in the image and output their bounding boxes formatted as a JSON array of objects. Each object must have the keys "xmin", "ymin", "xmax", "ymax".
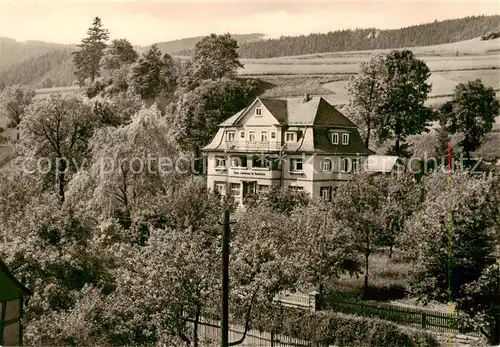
[{"xmin": 257, "ymin": 309, "xmax": 439, "ymax": 347}]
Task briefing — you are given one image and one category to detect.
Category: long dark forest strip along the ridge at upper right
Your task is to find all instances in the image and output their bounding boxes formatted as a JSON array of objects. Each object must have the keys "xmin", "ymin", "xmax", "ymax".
[{"xmin": 233, "ymin": 16, "xmax": 500, "ymax": 58}]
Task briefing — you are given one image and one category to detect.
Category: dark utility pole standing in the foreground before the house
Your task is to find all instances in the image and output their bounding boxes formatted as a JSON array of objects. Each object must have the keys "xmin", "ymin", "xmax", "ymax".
[{"xmin": 220, "ymin": 209, "xmax": 231, "ymax": 347}]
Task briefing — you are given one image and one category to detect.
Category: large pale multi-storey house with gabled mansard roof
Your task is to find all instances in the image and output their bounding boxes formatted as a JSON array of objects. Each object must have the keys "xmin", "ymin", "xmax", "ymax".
[{"xmin": 203, "ymin": 95, "xmax": 373, "ymax": 202}]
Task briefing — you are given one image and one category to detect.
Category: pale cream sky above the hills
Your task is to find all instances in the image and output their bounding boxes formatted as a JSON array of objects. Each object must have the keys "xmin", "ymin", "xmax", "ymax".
[{"xmin": 0, "ymin": 0, "xmax": 500, "ymax": 45}]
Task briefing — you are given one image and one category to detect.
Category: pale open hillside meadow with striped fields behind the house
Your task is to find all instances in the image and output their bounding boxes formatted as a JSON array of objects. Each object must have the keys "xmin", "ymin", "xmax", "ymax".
[{"xmin": 0, "ymin": 38, "xmax": 500, "ymax": 168}]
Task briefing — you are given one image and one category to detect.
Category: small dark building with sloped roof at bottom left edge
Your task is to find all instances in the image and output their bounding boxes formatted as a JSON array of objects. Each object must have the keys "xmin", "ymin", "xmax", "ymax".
[{"xmin": 0, "ymin": 258, "xmax": 32, "ymax": 346}]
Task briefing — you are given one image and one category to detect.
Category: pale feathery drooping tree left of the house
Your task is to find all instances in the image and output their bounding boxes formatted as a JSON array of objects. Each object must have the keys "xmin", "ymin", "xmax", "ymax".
[{"xmin": 68, "ymin": 106, "xmax": 177, "ymax": 228}]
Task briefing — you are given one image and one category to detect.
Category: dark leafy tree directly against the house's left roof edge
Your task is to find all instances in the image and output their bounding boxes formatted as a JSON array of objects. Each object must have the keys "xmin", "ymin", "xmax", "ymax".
[{"xmin": 170, "ymin": 78, "xmax": 258, "ymax": 169}]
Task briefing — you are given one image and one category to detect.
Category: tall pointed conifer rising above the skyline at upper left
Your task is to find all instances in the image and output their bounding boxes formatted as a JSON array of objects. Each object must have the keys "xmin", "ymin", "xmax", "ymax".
[{"xmin": 73, "ymin": 17, "xmax": 109, "ymax": 86}]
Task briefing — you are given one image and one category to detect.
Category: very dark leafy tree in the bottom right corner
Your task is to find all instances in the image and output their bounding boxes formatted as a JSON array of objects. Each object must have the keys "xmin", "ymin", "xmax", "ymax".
[{"xmin": 457, "ymin": 259, "xmax": 500, "ymax": 346}]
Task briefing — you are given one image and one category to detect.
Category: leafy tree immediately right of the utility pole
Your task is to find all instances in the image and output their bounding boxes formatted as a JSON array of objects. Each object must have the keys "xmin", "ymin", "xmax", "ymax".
[{"xmin": 229, "ymin": 206, "xmax": 302, "ymax": 344}]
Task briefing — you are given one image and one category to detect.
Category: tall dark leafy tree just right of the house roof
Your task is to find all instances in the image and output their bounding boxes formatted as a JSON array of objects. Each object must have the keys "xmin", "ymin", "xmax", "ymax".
[{"xmin": 377, "ymin": 50, "xmax": 433, "ymax": 156}]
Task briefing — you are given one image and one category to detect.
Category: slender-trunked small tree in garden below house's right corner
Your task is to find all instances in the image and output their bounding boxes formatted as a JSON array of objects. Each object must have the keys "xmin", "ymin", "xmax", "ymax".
[{"xmin": 334, "ymin": 173, "xmax": 387, "ymax": 298}]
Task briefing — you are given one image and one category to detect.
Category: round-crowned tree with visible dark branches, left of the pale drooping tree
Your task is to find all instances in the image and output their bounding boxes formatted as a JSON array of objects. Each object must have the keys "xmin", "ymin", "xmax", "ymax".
[{"xmin": 20, "ymin": 94, "xmax": 96, "ymax": 201}]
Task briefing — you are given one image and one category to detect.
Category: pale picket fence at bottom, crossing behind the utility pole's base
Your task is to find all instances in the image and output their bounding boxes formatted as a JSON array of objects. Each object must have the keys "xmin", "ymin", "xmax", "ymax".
[{"xmin": 188, "ymin": 318, "xmax": 329, "ymax": 347}]
